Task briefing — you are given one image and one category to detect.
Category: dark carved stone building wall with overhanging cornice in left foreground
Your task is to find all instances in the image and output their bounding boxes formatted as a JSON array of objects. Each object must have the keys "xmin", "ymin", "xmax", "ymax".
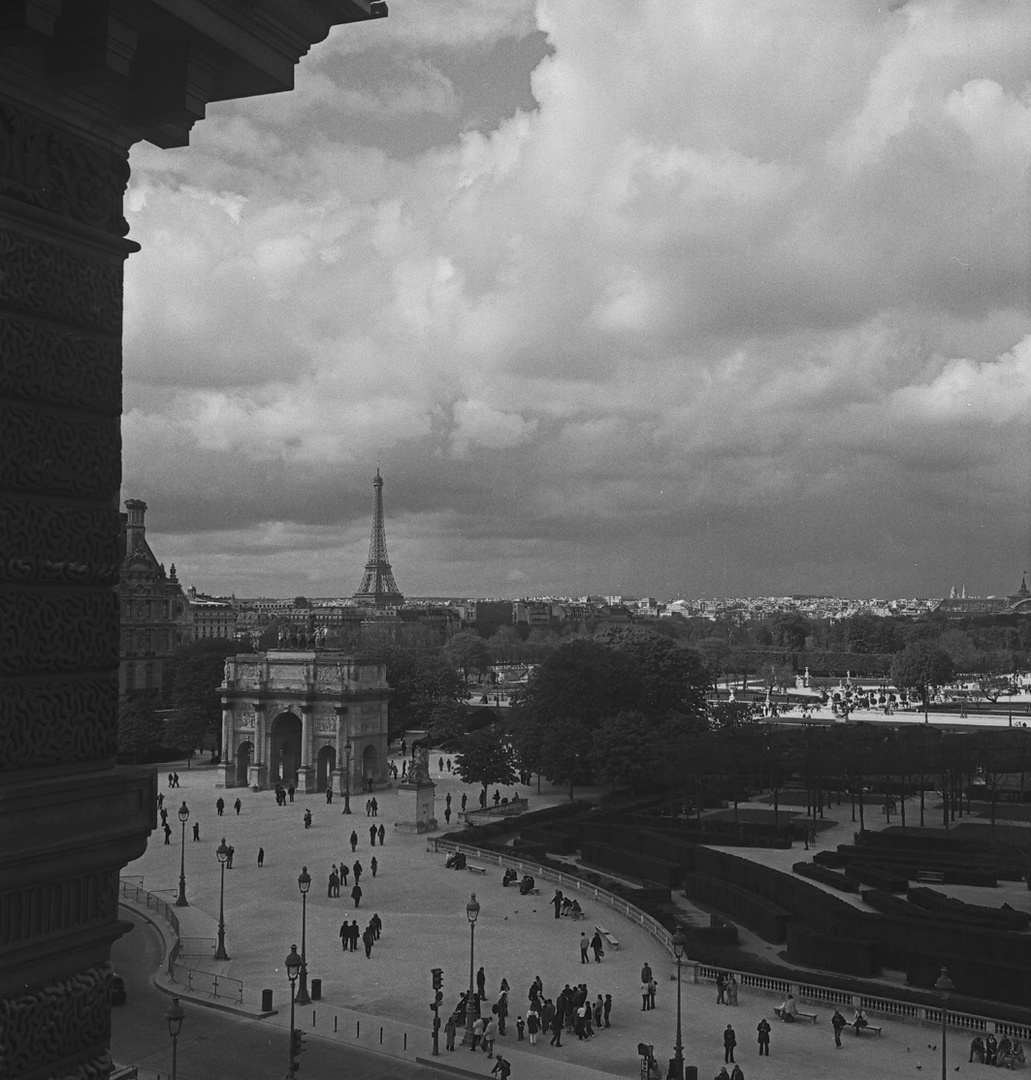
[{"xmin": 0, "ymin": 0, "xmax": 386, "ymax": 1080}]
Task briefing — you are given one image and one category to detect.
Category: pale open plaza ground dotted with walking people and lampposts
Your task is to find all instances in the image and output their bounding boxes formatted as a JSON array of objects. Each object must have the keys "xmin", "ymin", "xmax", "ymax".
[{"xmin": 124, "ymin": 756, "xmax": 993, "ymax": 1080}]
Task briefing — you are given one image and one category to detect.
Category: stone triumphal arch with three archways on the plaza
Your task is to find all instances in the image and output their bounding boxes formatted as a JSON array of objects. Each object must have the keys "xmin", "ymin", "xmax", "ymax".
[{"xmin": 218, "ymin": 649, "xmax": 390, "ymax": 792}]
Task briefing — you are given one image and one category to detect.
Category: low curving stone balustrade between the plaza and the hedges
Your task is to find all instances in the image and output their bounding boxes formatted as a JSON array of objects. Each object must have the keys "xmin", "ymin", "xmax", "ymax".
[{"xmin": 431, "ymin": 838, "xmax": 1031, "ymax": 1042}]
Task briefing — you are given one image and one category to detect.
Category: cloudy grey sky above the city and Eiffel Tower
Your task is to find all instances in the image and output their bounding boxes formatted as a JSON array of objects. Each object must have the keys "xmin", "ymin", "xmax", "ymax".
[{"xmin": 123, "ymin": 0, "xmax": 1031, "ymax": 596}]
